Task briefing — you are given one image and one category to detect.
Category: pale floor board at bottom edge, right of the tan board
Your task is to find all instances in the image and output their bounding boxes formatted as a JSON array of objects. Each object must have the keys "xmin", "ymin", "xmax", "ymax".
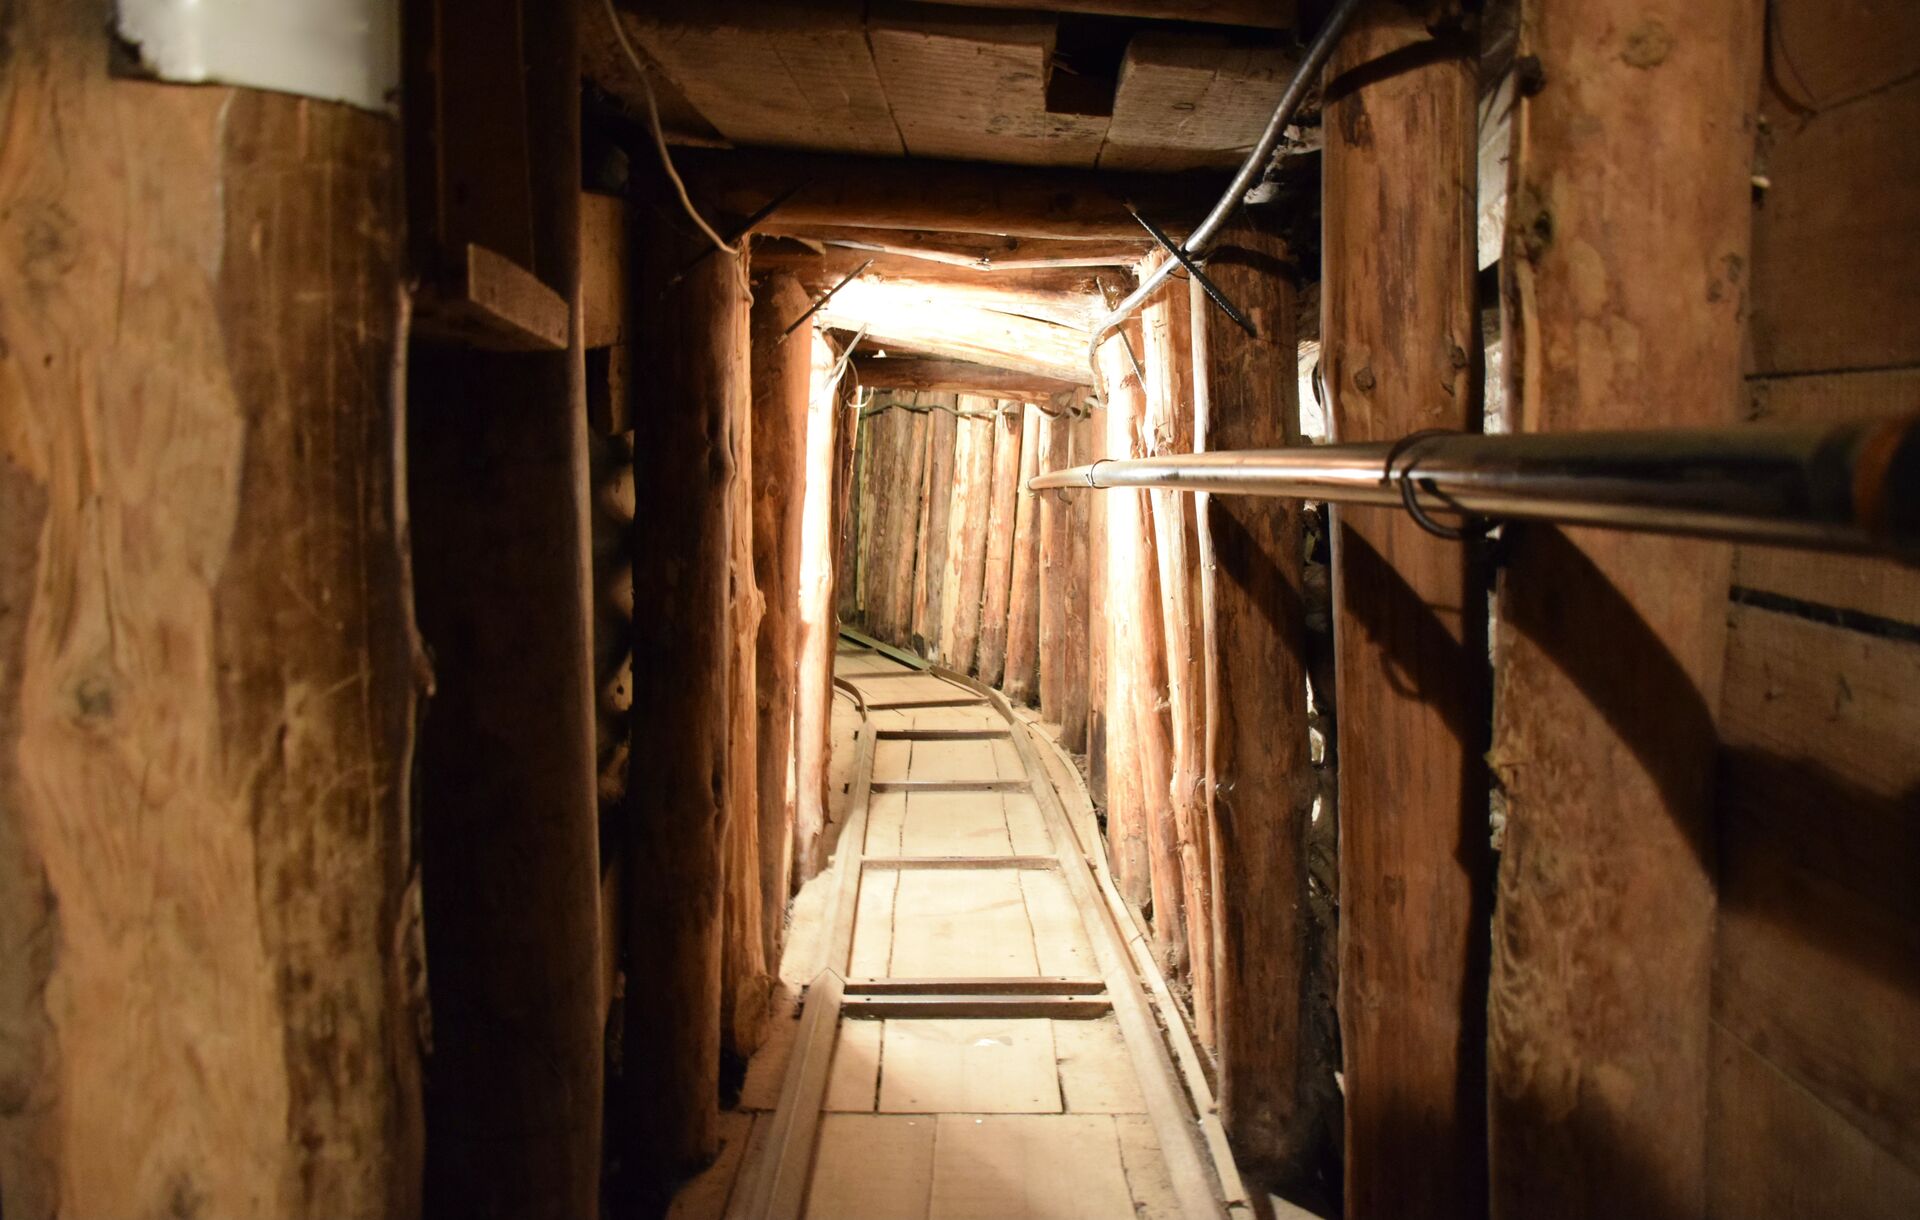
[{"xmin": 927, "ymin": 1114, "xmax": 1133, "ymax": 1220}]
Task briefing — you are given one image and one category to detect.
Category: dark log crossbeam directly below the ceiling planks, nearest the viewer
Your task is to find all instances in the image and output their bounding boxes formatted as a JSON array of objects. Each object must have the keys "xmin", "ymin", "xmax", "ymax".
[{"xmin": 674, "ymin": 148, "xmax": 1225, "ymax": 240}]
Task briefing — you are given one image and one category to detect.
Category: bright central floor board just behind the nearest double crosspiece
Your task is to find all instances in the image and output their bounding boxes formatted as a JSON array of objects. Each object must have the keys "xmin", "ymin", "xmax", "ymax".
[{"xmin": 890, "ymin": 868, "xmax": 1041, "ymax": 978}]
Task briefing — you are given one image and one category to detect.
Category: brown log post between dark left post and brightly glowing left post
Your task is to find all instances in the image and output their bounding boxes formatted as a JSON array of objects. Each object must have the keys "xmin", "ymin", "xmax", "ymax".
[{"xmin": 753, "ymin": 273, "xmax": 814, "ymax": 970}]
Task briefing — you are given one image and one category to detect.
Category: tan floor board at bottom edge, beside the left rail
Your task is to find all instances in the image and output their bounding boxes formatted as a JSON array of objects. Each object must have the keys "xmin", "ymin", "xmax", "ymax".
[{"xmin": 806, "ymin": 1114, "xmax": 935, "ymax": 1220}]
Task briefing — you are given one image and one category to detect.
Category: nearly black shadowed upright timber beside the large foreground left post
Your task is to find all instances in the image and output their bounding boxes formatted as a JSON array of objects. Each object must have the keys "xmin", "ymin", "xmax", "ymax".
[{"xmin": 407, "ymin": 6, "xmax": 605, "ymax": 1216}]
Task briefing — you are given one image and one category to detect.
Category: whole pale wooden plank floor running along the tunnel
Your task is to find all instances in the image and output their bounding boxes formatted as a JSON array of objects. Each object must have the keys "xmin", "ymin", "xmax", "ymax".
[{"xmin": 674, "ymin": 644, "xmax": 1217, "ymax": 1220}]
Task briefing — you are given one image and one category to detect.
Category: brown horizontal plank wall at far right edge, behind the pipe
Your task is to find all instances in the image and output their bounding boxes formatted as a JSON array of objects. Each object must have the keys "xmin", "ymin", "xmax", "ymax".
[{"xmin": 1707, "ymin": 0, "xmax": 1920, "ymax": 1220}]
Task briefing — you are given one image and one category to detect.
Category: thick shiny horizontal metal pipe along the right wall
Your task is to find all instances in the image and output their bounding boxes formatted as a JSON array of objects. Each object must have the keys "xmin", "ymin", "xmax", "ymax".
[{"xmin": 1029, "ymin": 415, "xmax": 1920, "ymax": 559}]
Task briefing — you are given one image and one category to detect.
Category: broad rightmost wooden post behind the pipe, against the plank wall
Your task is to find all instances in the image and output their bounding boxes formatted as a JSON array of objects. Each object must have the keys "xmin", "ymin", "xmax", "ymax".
[{"xmin": 1474, "ymin": 0, "xmax": 1763, "ymax": 1216}]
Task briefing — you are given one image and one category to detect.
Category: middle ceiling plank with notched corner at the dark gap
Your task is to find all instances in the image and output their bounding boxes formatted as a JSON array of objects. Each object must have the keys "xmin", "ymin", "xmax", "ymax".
[{"xmin": 868, "ymin": 4, "xmax": 1108, "ymax": 167}]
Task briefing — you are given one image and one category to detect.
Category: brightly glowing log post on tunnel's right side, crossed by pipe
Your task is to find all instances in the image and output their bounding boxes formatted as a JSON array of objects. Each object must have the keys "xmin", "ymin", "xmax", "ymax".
[{"xmin": 1100, "ymin": 325, "xmax": 1152, "ymax": 907}]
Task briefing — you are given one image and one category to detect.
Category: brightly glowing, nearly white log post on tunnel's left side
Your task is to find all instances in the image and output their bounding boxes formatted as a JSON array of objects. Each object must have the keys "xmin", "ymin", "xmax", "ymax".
[{"xmin": 794, "ymin": 344, "xmax": 852, "ymax": 887}]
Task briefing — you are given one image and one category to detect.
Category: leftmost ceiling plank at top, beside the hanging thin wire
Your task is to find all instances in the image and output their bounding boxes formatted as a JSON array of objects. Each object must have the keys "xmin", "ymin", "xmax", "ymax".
[{"xmin": 620, "ymin": 0, "xmax": 906, "ymax": 156}]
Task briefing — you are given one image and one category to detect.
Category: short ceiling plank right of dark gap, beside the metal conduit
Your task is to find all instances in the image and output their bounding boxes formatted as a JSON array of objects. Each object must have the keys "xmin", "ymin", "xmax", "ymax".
[{"xmin": 1100, "ymin": 31, "xmax": 1294, "ymax": 171}]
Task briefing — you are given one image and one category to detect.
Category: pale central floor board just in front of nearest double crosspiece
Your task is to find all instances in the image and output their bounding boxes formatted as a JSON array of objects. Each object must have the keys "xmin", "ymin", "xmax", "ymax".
[{"xmin": 879, "ymin": 1018, "xmax": 1060, "ymax": 1114}]
